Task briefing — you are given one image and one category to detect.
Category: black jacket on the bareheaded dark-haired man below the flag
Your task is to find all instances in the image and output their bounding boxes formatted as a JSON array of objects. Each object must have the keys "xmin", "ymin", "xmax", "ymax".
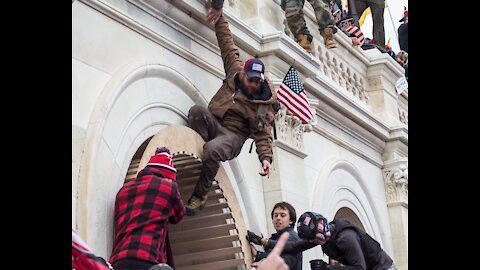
[{"xmin": 255, "ymin": 227, "xmax": 303, "ymax": 270}]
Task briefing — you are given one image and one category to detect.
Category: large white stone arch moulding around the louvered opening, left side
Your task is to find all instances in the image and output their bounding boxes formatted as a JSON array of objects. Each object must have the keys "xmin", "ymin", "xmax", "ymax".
[{"xmin": 72, "ymin": 60, "xmax": 207, "ymax": 258}]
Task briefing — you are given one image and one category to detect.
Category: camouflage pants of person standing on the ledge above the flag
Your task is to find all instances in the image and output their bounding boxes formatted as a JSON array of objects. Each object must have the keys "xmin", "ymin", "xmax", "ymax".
[{"xmin": 281, "ymin": 0, "xmax": 334, "ymax": 41}]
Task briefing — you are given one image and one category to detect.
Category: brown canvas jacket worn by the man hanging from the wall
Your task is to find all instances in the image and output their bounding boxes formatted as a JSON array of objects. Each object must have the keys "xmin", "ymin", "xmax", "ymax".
[{"xmin": 208, "ymin": 16, "xmax": 277, "ymax": 162}]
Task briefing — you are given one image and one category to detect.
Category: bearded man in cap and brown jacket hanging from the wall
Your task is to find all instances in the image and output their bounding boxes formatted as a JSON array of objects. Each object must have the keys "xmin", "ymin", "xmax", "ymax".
[{"xmin": 186, "ymin": 0, "xmax": 278, "ymax": 216}]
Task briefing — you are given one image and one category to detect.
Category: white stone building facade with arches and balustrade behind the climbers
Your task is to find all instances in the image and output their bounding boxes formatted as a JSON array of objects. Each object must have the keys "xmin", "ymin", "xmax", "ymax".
[{"xmin": 72, "ymin": 0, "xmax": 408, "ymax": 270}]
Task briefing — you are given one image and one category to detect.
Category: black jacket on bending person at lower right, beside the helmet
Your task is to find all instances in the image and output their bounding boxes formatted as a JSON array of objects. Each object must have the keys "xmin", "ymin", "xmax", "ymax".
[{"xmin": 322, "ymin": 219, "xmax": 393, "ymax": 270}]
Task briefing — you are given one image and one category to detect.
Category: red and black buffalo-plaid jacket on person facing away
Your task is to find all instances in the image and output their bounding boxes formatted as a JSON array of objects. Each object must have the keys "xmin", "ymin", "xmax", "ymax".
[{"xmin": 109, "ymin": 166, "xmax": 185, "ymax": 264}]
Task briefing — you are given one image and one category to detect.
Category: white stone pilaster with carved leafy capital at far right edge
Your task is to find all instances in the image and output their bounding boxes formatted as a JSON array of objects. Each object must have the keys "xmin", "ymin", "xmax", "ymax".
[{"xmin": 383, "ymin": 158, "xmax": 408, "ymax": 270}]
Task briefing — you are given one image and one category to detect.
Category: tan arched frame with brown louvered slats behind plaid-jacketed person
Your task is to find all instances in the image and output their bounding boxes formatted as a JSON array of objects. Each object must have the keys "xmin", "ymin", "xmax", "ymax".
[{"xmin": 133, "ymin": 125, "xmax": 252, "ymax": 270}]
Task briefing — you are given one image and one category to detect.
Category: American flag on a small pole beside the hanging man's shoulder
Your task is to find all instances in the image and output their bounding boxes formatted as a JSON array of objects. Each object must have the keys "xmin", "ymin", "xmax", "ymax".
[{"xmin": 277, "ymin": 66, "xmax": 313, "ymax": 124}]
